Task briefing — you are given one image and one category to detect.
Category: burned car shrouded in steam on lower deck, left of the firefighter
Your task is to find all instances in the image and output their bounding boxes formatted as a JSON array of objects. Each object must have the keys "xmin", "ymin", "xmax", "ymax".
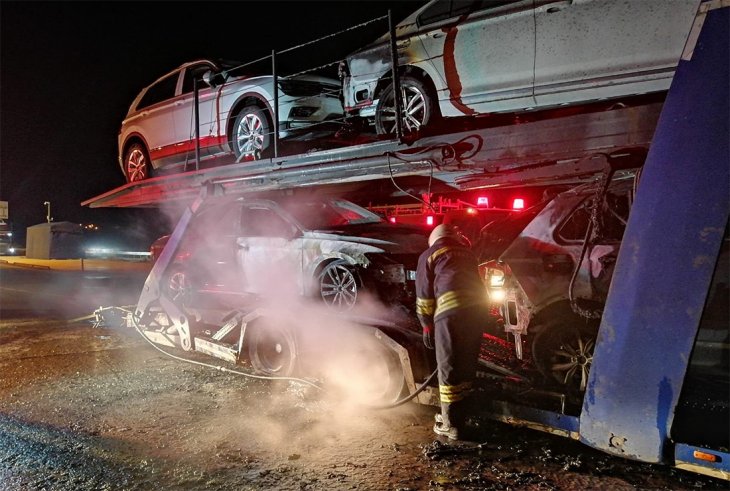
[{"xmin": 162, "ymin": 197, "xmax": 426, "ymax": 311}]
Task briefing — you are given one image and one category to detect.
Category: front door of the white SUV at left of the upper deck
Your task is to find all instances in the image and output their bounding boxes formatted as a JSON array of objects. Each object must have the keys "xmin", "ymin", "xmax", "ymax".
[{"xmin": 173, "ymin": 61, "xmax": 222, "ymax": 164}]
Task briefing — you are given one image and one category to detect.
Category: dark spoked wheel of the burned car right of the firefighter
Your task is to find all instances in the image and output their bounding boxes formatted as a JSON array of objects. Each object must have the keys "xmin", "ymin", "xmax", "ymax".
[{"xmin": 532, "ymin": 315, "xmax": 598, "ymax": 393}]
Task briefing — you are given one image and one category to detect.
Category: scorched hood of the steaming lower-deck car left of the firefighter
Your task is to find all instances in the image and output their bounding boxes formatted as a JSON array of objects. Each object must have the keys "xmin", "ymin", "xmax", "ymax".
[{"xmin": 304, "ymin": 224, "xmax": 428, "ymax": 254}]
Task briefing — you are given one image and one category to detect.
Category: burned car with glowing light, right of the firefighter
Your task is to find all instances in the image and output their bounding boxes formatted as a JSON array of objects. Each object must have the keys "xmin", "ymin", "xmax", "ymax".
[{"xmin": 477, "ymin": 173, "xmax": 634, "ymax": 393}]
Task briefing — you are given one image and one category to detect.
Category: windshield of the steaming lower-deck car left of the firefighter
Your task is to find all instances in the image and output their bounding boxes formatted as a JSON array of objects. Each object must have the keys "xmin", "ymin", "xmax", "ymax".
[{"xmin": 282, "ymin": 200, "xmax": 383, "ymax": 230}]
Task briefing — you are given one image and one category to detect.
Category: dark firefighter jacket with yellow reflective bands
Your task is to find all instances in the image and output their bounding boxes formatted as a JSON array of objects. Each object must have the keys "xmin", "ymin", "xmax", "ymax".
[{"xmin": 416, "ymin": 237, "xmax": 486, "ymax": 327}]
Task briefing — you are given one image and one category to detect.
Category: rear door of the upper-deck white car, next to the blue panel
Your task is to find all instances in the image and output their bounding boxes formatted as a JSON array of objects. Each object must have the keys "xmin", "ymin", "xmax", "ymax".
[{"xmin": 535, "ymin": 0, "xmax": 699, "ymax": 106}]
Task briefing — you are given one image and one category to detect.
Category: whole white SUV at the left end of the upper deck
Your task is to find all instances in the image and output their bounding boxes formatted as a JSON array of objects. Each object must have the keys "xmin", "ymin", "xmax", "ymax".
[{"xmin": 119, "ymin": 60, "xmax": 343, "ymax": 182}]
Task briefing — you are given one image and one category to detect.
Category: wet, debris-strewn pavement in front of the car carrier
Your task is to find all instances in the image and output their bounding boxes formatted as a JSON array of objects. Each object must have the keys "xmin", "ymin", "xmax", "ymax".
[{"xmin": 0, "ymin": 264, "xmax": 730, "ymax": 491}]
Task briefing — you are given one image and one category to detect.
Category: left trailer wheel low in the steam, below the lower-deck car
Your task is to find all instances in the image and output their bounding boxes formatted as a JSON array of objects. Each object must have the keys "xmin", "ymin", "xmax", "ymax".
[{"xmin": 247, "ymin": 324, "xmax": 297, "ymax": 377}]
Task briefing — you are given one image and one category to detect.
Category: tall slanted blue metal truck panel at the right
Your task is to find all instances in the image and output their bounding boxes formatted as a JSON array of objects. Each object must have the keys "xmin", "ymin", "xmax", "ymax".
[{"xmin": 580, "ymin": 2, "xmax": 730, "ymax": 463}]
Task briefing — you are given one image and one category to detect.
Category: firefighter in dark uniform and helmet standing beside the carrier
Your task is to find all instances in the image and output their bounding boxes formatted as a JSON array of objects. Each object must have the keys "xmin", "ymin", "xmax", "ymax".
[{"xmin": 416, "ymin": 224, "xmax": 488, "ymax": 440}]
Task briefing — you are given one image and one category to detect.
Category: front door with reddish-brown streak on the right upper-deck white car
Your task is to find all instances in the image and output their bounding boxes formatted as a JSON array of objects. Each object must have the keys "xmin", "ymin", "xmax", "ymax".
[{"xmin": 418, "ymin": 0, "xmax": 535, "ymax": 116}]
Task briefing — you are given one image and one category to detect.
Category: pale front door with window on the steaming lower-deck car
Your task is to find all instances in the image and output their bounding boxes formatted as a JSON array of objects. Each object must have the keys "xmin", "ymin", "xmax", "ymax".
[{"xmin": 237, "ymin": 204, "xmax": 302, "ymax": 298}]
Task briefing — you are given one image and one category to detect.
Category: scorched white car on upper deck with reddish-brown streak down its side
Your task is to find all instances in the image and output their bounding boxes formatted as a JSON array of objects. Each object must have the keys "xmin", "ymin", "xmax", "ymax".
[{"xmin": 340, "ymin": 0, "xmax": 700, "ymax": 134}]
